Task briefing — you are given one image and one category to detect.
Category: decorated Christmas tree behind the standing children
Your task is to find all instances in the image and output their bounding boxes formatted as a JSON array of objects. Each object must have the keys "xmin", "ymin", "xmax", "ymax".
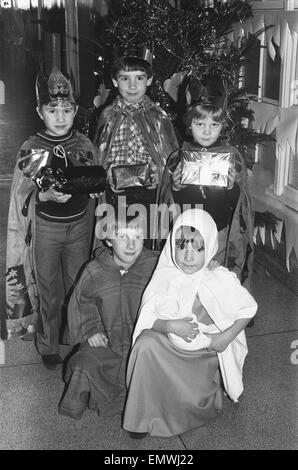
[{"xmin": 96, "ymin": 0, "xmax": 270, "ymax": 167}]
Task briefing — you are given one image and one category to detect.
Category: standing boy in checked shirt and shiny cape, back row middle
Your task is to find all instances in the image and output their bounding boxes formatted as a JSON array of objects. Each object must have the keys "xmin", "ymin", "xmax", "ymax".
[{"xmin": 95, "ymin": 48, "xmax": 177, "ymax": 248}]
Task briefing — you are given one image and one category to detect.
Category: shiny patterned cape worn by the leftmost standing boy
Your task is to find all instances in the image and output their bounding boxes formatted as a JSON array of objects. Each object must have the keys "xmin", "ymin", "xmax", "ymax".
[{"xmin": 6, "ymin": 131, "xmax": 96, "ymax": 338}]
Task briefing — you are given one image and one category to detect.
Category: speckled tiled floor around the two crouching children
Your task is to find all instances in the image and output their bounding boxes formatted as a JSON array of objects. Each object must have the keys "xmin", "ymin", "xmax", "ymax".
[{"xmin": 0, "ymin": 262, "xmax": 298, "ymax": 451}]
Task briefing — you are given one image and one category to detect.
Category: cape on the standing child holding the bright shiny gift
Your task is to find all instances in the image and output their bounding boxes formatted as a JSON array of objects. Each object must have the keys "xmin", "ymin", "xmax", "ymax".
[{"xmin": 159, "ymin": 142, "xmax": 254, "ymax": 289}]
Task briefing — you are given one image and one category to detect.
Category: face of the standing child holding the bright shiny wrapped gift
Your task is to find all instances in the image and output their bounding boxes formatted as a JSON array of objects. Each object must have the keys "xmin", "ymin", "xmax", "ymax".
[{"xmin": 190, "ymin": 116, "xmax": 223, "ymax": 147}]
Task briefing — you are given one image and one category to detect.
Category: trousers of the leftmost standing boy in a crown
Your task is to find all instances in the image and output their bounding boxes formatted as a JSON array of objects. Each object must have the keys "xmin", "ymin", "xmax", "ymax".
[{"xmin": 34, "ymin": 214, "xmax": 89, "ymax": 354}]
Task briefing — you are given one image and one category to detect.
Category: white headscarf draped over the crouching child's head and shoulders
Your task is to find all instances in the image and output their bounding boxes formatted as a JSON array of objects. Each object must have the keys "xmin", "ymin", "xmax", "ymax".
[{"xmin": 133, "ymin": 209, "xmax": 257, "ymax": 401}]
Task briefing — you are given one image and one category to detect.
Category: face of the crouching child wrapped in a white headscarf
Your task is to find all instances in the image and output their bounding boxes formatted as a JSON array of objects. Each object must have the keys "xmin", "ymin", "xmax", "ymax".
[{"xmin": 175, "ymin": 227, "xmax": 205, "ymax": 274}]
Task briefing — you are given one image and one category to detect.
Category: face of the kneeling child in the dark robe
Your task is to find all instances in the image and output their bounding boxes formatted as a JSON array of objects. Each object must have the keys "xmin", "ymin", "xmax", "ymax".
[{"xmin": 110, "ymin": 227, "xmax": 144, "ymax": 269}]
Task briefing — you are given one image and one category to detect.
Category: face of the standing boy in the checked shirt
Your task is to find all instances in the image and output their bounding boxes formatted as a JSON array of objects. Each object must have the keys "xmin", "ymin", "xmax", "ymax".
[{"xmin": 113, "ymin": 70, "xmax": 152, "ymax": 104}]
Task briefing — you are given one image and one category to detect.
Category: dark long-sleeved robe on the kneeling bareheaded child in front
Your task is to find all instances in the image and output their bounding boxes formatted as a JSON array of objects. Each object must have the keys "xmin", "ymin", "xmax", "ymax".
[{"xmin": 59, "ymin": 249, "xmax": 158, "ymax": 419}]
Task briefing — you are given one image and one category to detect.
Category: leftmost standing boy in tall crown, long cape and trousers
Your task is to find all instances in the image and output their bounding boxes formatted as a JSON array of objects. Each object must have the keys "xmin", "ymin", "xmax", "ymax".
[{"xmin": 6, "ymin": 67, "xmax": 101, "ymax": 369}]
